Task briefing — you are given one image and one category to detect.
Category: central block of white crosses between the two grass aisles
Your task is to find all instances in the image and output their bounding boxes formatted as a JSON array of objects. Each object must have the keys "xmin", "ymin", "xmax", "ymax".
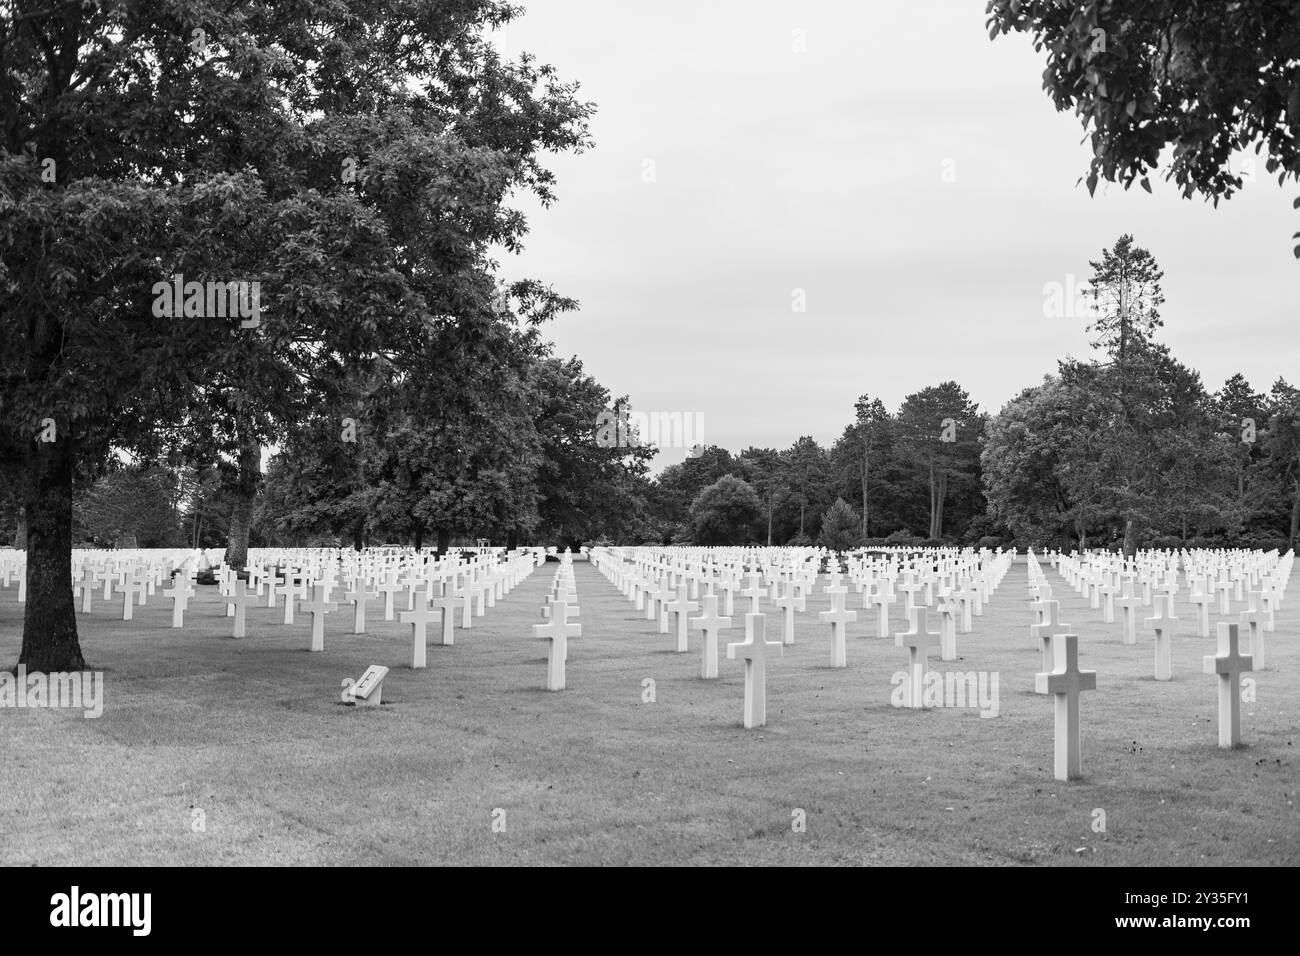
[{"xmin": 592, "ymin": 549, "xmax": 1013, "ymax": 727}]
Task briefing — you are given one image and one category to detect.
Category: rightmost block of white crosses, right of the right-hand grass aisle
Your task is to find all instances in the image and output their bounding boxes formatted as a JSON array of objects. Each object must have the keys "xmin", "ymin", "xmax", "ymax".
[{"xmin": 1028, "ymin": 551, "xmax": 1294, "ymax": 780}]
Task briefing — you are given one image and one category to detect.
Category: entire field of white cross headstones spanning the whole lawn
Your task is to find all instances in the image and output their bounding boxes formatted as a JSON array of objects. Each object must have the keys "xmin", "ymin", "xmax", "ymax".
[{"xmin": 0, "ymin": 546, "xmax": 1295, "ymax": 780}]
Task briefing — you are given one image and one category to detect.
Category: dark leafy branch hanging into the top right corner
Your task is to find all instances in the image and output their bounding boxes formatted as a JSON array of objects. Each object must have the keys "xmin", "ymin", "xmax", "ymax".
[{"xmin": 987, "ymin": 0, "xmax": 1300, "ymax": 256}]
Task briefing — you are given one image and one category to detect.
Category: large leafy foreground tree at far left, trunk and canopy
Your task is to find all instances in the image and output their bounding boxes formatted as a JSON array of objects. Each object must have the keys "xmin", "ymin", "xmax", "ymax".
[{"xmin": 0, "ymin": 0, "xmax": 590, "ymax": 670}]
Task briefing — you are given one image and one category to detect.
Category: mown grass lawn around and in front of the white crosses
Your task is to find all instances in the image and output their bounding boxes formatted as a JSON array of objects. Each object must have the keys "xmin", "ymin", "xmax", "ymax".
[{"xmin": 0, "ymin": 558, "xmax": 1300, "ymax": 866}]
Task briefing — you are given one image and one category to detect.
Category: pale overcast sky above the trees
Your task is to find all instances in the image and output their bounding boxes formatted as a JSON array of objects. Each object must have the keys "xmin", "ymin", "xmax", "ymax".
[{"xmin": 497, "ymin": 0, "xmax": 1300, "ymax": 468}]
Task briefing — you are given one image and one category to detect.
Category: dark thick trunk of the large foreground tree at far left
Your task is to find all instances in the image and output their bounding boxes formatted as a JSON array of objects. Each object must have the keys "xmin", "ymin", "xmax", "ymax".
[{"xmin": 18, "ymin": 434, "xmax": 86, "ymax": 674}]
